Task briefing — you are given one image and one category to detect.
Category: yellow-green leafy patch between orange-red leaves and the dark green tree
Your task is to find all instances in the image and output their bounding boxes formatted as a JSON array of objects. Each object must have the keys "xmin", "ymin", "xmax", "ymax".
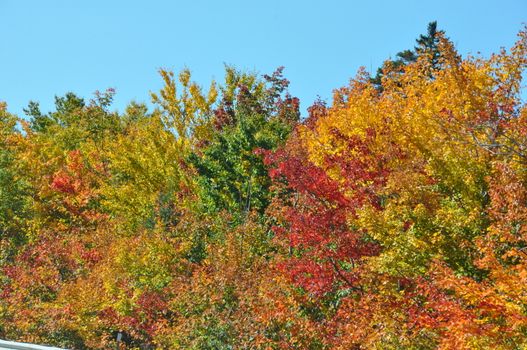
[{"xmin": 100, "ymin": 115, "xmax": 191, "ymax": 228}]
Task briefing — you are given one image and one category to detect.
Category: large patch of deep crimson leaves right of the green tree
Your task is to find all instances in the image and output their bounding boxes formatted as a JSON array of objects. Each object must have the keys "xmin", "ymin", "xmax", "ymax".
[{"xmin": 265, "ymin": 129, "xmax": 387, "ymax": 295}]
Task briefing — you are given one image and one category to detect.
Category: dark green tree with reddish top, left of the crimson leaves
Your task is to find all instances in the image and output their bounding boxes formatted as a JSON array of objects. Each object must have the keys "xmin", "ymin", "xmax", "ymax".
[{"xmin": 189, "ymin": 67, "xmax": 299, "ymax": 215}]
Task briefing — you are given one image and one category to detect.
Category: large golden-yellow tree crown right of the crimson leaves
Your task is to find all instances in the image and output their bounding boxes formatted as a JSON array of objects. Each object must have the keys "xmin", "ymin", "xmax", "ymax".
[{"xmin": 299, "ymin": 40, "xmax": 506, "ymax": 284}]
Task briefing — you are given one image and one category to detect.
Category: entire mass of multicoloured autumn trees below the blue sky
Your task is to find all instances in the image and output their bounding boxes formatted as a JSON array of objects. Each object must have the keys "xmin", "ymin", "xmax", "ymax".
[{"xmin": 0, "ymin": 26, "xmax": 527, "ymax": 349}]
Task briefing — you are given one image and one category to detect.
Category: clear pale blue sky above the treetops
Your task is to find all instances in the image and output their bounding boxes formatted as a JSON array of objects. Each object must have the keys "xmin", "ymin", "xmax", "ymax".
[{"xmin": 0, "ymin": 0, "xmax": 527, "ymax": 116}]
